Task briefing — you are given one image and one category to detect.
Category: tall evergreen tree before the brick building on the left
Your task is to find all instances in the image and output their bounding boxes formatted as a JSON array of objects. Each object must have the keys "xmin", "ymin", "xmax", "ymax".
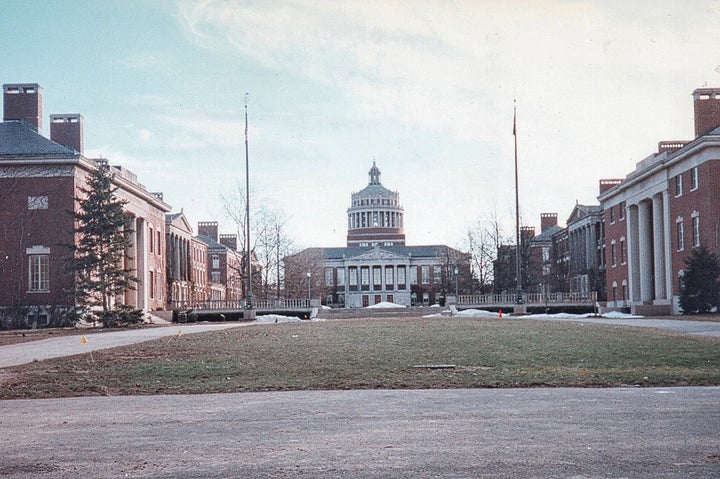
[{"xmin": 70, "ymin": 162, "xmax": 139, "ymax": 326}]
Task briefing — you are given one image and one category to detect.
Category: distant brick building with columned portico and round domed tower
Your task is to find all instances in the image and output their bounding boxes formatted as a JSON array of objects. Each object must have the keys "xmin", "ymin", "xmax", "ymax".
[{"xmin": 285, "ymin": 161, "xmax": 471, "ymax": 308}]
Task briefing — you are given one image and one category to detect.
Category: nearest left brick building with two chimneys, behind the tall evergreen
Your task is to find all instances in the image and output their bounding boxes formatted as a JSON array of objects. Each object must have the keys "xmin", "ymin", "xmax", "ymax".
[{"xmin": 0, "ymin": 83, "xmax": 170, "ymax": 324}]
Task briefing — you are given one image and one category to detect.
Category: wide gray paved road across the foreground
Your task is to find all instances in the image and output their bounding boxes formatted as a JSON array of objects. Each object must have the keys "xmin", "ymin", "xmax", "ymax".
[{"xmin": 0, "ymin": 387, "xmax": 720, "ymax": 479}]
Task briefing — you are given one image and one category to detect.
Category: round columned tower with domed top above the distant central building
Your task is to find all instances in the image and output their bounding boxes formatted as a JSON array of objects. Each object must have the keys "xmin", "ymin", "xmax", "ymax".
[{"xmin": 347, "ymin": 161, "xmax": 405, "ymax": 246}]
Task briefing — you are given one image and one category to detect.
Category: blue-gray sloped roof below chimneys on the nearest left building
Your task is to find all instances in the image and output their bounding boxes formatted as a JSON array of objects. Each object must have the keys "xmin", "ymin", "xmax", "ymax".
[{"xmin": 0, "ymin": 121, "xmax": 77, "ymax": 156}]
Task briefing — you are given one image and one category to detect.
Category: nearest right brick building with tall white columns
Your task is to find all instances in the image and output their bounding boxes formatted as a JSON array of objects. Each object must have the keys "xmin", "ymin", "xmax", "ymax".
[{"xmin": 598, "ymin": 88, "xmax": 720, "ymax": 314}]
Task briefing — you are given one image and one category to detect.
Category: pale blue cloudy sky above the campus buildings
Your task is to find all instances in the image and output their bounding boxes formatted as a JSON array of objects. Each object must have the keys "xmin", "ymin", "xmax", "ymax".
[{"xmin": 0, "ymin": 0, "xmax": 720, "ymax": 249}]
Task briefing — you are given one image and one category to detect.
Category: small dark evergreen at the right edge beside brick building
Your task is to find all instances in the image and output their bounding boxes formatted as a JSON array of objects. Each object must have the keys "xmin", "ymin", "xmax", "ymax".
[{"xmin": 680, "ymin": 246, "xmax": 720, "ymax": 314}]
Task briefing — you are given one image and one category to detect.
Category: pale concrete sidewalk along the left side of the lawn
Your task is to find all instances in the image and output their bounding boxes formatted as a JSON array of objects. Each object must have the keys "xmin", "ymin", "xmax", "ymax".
[{"xmin": 0, "ymin": 322, "xmax": 248, "ymax": 368}]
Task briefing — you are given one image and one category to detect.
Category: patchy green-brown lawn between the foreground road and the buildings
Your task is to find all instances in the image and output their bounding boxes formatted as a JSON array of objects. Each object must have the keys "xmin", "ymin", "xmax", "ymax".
[{"xmin": 0, "ymin": 318, "xmax": 720, "ymax": 399}]
